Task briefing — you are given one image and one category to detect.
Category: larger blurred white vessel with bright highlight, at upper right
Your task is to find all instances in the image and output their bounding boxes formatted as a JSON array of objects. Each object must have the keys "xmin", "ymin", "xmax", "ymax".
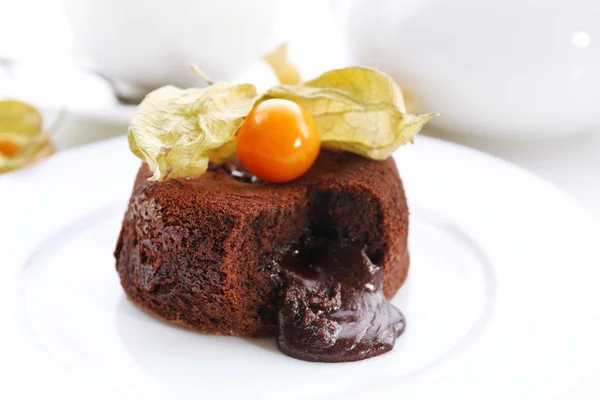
[{"xmin": 335, "ymin": 0, "xmax": 600, "ymax": 138}]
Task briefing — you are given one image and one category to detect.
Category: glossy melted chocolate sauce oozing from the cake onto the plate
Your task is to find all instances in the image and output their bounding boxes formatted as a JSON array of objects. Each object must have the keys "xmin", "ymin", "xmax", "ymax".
[{"xmin": 277, "ymin": 238, "xmax": 405, "ymax": 362}]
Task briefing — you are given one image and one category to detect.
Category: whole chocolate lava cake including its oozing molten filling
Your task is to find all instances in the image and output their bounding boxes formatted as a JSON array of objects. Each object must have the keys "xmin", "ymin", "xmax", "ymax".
[{"xmin": 115, "ymin": 149, "xmax": 409, "ymax": 362}]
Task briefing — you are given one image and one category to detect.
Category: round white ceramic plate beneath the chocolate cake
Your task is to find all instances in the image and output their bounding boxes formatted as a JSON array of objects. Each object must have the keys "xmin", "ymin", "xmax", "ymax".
[{"xmin": 0, "ymin": 138, "xmax": 600, "ymax": 399}]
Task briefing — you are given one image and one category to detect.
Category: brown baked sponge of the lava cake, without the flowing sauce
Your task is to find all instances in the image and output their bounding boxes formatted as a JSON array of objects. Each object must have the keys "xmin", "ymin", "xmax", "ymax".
[{"xmin": 115, "ymin": 150, "xmax": 409, "ymax": 338}]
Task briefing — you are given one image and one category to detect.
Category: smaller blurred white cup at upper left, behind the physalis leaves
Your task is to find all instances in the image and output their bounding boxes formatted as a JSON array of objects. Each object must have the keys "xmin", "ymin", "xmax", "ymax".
[{"xmin": 66, "ymin": 0, "xmax": 277, "ymax": 99}]
